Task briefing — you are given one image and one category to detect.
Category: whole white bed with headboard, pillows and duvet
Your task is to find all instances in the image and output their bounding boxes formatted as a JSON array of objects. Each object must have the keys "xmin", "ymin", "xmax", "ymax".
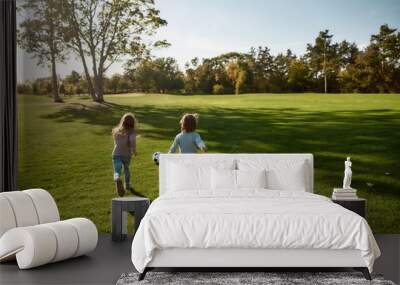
[{"xmin": 132, "ymin": 154, "xmax": 380, "ymax": 278}]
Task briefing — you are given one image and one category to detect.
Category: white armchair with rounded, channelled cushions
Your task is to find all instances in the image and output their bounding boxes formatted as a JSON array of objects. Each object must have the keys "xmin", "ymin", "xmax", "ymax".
[{"xmin": 0, "ymin": 189, "xmax": 98, "ymax": 269}]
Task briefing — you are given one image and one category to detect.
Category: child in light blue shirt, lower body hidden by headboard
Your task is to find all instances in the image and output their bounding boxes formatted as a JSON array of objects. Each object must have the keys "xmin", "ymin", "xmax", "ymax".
[{"xmin": 169, "ymin": 114, "xmax": 207, "ymax": 153}]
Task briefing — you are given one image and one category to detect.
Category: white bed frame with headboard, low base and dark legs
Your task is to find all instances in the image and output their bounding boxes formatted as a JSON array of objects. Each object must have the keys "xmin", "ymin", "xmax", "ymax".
[{"xmin": 139, "ymin": 154, "xmax": 371, "ymax": 280}]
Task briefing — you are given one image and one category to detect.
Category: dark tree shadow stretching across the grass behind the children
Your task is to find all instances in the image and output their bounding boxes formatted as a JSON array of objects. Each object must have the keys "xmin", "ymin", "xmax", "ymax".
[{"xmin": 43, "ymin": 102, "xmax": 400, "ymax": 195}]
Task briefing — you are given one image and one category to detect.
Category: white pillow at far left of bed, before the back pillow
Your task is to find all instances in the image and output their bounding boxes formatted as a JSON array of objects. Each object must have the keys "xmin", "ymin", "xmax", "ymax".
[{"xmin": 167, "ymin": 163, "xmax": 211, "ymax": 191}]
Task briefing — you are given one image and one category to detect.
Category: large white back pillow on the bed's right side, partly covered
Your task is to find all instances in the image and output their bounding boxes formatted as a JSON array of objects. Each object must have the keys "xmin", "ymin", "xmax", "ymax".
[{"xmin": 238, "ymin": 160, "xmax": 309, "ymax": 192}]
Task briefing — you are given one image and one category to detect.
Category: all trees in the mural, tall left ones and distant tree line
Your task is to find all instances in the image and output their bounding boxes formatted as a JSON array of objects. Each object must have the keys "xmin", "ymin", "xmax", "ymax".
[{"xmin": 18, "ymin": 0, "xmax": 400, "ymax": 102}]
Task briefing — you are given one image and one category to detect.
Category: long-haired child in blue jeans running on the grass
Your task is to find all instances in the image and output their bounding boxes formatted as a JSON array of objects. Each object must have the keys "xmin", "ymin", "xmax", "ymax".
[{"xmin": 112, "ymin": 113, "xmax": 137, "ymax": 197}]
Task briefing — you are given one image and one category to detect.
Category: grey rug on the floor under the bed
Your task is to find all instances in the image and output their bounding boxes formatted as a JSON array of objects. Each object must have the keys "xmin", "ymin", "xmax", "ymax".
[{"xmin": 117, "ymin": 272, "xmax": 395, "ymax": 285}]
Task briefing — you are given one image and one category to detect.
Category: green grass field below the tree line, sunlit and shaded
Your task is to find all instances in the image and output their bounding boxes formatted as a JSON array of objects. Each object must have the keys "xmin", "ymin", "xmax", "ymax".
[{"xmin": 18, "ymin": 94, "xmax": 400, "ymax": 233}]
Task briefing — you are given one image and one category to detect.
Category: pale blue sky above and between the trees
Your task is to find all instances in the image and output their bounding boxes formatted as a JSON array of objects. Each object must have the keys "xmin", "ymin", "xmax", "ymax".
[{"xmin": 18, "ymin": 0, "xmax": 400, "ymax": 81}]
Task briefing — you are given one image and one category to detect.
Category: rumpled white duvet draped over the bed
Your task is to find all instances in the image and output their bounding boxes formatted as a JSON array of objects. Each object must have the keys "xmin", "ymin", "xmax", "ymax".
[{"xmin": 132, "ymin": 190, "xmax": 380, "ymax": 272}]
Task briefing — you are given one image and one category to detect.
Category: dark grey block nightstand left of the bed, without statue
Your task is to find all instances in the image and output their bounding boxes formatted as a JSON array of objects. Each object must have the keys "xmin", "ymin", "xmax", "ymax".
[{"xmin": 111, "ymin": 196, "xmax": 150, "ymax": 241}]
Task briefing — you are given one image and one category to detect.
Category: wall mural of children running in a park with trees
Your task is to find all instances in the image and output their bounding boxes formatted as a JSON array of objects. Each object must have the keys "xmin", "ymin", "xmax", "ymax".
[{"xmin": 18, "ymin": 0, "xmax": 400, "ymax": 233}]
